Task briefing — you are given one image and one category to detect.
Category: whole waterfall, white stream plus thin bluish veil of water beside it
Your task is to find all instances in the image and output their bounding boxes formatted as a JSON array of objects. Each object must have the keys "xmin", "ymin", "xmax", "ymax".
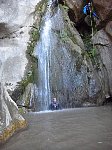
[{"xmin": 36, "ymin": 0, "xmax": 83, "ymax": 111}]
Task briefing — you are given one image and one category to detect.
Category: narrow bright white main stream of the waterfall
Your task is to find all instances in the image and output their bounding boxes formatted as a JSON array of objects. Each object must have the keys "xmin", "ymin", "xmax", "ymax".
[{"xmin": 36, "ymin": 0, "xmax": 52, "ymax": 110}]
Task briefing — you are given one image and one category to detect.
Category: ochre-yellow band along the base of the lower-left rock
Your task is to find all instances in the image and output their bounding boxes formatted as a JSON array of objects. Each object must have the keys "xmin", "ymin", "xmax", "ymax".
[{"xmin": 0, "ymin": 120, "xmax": 27, "ymax": 144}]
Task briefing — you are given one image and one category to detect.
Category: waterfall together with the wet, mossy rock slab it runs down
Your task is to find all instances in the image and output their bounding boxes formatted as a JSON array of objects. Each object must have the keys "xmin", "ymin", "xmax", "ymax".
[{"xmin": 35, "ymin": 0, "xmax": 96, "ymax": 111}]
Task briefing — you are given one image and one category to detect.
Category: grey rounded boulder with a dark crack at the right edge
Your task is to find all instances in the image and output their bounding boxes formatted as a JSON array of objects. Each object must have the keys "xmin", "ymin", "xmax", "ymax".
[{"xmin": 92, "ymin": 30, "xmax": 112, "ymax": 95}]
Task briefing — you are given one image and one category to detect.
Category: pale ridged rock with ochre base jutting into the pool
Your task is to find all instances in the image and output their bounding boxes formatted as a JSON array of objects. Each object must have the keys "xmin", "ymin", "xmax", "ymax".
[{"xmin": 0, "ymin": 85, "xmax": 27, "ymax": 143}]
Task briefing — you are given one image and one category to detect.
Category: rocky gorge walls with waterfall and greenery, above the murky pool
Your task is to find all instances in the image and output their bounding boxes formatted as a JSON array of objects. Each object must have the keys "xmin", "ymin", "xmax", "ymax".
[{"xmin": 0, "ymin": 0, "xmax": 112, "ymax": 145}]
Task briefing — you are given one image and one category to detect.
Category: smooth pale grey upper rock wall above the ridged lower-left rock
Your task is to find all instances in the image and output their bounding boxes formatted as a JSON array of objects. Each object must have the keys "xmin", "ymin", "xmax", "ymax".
[{"xmin": 0, "ymin": 0, "xmax": 38, "ymax": 89}]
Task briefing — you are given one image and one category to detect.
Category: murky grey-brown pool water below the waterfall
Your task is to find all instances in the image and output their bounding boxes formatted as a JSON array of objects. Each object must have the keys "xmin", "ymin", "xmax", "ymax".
[{"xmin": 0, "ymin": 106, "xmax": 112, "ymax": 150}]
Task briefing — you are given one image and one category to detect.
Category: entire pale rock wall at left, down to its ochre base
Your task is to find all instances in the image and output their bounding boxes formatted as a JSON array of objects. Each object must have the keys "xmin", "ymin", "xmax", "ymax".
[{"xmin": 0, "ymin": 0, "xmax": 39, "ymax": 142}]
